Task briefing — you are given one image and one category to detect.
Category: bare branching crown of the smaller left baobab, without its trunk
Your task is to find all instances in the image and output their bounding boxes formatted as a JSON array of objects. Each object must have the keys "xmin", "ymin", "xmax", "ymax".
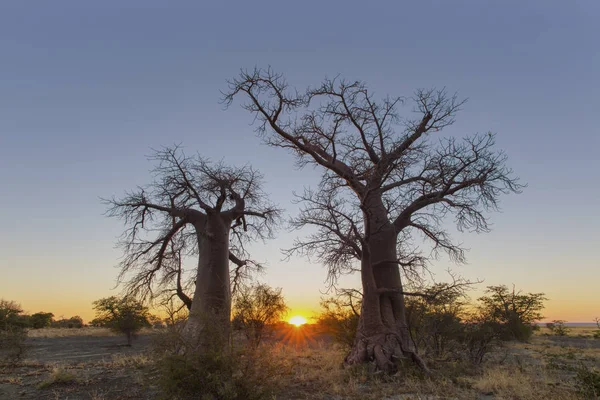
[{"xmin": 104, "ymin": 146, "xmax": 280, "ymax": 308}]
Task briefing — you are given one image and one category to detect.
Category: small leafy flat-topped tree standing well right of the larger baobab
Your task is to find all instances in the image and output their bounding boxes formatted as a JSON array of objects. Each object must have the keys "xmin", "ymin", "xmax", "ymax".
[{"xmin": 479, "ymin": 285, "xmax": 547, "ymax": 341}]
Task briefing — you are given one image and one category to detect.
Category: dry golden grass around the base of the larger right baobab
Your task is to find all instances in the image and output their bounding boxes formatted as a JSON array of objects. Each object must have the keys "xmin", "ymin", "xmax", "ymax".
[{"xmin": 250, "ymin": 337, "xmax": 600, "ymax": 400}]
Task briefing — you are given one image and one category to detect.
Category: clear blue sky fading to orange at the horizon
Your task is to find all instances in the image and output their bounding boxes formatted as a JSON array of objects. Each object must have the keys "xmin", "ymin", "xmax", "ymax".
[{"xmin": 0, "ymin": 0, "xmax": 600, "ymax": 322}]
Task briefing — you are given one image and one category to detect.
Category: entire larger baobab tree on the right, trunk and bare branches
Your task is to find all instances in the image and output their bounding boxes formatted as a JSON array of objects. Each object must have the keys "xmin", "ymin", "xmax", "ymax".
[{"xmin": 224, "ymin": 69, "xmax": 522, "ymax": 371}]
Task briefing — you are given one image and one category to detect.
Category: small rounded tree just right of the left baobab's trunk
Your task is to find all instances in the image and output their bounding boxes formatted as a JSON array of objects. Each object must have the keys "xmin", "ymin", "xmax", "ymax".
[{"xmin": 233, "ymin": 283, "xmax": 288, "ymax": 347}]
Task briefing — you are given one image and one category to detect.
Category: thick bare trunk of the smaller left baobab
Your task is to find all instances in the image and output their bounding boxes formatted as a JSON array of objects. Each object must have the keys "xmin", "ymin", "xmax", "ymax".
[{"xmin": 183, "ymin": 215, "xmax": 231, "ymax": 352}]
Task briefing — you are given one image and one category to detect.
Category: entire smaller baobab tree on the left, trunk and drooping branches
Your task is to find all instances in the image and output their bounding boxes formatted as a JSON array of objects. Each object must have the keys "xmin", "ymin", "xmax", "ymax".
[{"xmin": 106, "ymin": 147, "xmax": 279, "ymax": 349}]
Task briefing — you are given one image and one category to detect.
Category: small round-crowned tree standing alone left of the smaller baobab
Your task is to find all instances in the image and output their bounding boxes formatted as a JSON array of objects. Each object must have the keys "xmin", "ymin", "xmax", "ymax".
[{"xmin": 93, "ymin": 296, "xmax": 150, "ymax": 346}]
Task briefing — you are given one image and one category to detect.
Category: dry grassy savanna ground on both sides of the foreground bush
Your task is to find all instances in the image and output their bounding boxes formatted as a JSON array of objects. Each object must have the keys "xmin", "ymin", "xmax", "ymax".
[{"xmin": 0, "ymin": 326, "xmax": 600, "ymax": 400}]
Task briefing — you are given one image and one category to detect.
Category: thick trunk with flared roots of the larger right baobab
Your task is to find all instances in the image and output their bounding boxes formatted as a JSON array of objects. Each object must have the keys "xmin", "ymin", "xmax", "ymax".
[{"xmin": 345, "ymin": 197, "xmax": 428, "ymax": 373}]
